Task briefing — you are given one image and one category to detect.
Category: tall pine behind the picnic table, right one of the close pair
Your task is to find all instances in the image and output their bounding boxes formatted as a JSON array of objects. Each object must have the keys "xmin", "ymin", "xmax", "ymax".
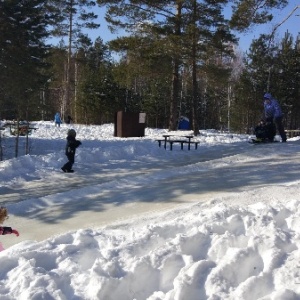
[{"xmin": 183, "ymin": 0, "xmax": 236, "ymax": 135}]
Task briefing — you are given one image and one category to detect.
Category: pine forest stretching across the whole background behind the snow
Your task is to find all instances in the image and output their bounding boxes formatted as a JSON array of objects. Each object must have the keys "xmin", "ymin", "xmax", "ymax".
[{"xmin": 0, "ymin": 0, "xmax": 300, "ymax": 134}]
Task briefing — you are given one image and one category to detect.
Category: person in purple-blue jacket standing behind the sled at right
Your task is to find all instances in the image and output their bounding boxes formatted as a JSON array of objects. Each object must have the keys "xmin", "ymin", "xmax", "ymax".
[{"xmin": 264, "ymin": 93, "xmax": 286, "ymax": 143}]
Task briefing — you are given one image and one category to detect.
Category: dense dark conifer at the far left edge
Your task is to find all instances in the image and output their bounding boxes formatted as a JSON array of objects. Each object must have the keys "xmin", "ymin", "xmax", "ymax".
[{"xmin": 0, "ymin": 0, "xmax": 52, "ymax": 119}]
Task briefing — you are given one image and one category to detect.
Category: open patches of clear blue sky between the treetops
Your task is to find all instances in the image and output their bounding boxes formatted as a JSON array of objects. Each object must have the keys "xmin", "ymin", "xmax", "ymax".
[{"xmin": 83, "ymin": 0, "xmax": 300, "ymax": 51}]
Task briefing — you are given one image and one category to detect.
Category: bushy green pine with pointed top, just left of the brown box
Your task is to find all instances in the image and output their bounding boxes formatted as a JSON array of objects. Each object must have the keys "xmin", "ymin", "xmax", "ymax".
[{"xmin": 76, "ymin": 38, "xmax": 119, "ymax": 124}]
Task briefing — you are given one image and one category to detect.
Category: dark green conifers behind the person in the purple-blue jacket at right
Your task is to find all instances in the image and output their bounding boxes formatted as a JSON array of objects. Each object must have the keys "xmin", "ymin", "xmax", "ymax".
[{"xmin": 235, "ymin": 33, "xmax": 300, "ymax": 133}]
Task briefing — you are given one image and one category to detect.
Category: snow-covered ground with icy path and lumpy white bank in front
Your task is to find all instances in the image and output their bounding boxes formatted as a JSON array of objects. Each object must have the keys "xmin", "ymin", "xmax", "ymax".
[{"xmin": 0, "ymin": 122, "xmax": 300, "ymax": 300}]
